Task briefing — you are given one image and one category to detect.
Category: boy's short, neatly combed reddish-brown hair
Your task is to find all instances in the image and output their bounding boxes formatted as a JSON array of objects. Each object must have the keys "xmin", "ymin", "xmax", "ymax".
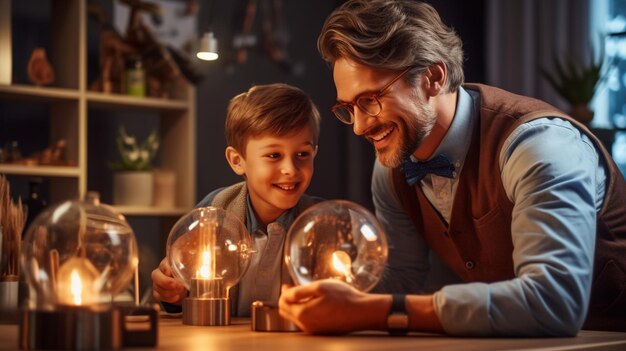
[{"xmin": 225, "ymin": 83, "xmax": 320, "ymax": 157}]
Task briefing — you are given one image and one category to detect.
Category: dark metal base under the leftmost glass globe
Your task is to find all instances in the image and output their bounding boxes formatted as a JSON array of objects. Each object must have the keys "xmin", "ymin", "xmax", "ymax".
[{"xmin": 19, "ymin": 306, "xmax": 122, "ymax": 350}]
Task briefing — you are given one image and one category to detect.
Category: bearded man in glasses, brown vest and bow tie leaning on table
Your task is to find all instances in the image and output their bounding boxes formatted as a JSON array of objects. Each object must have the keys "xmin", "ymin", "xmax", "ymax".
[{"xmin": 280, "ymin": 0, "xmax": 626, "ymax": 336}]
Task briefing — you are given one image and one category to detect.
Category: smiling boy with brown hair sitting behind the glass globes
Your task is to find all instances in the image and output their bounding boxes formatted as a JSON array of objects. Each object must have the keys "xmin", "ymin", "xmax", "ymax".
[{"xmin": 152, "ymin": 84, "xmax": 320, "ymax": 317}]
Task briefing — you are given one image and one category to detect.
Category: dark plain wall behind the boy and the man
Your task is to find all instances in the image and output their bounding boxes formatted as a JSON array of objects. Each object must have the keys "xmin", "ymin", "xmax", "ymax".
[{"xmin": 197, "ymin": 0, "xmax": 484, "ymax": 208}]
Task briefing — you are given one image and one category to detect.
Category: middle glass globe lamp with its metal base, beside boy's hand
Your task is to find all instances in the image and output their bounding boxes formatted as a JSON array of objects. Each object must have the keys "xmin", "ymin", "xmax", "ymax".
[{"xmin": 167, "ymin": 207, "xmax": 252, "ymax": 325}]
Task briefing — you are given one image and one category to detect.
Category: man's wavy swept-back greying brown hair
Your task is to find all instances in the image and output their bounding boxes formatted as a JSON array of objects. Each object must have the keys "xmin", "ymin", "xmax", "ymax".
[{"xmin": 317, "ymin": 0, "xmax": 465, "ymax": 92}]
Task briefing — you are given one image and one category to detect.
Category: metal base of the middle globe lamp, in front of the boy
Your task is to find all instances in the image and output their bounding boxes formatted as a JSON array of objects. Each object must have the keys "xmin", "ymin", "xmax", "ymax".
[{"xmin": 183, "ymin": 297, "xmax": 230, "ymax": 326}]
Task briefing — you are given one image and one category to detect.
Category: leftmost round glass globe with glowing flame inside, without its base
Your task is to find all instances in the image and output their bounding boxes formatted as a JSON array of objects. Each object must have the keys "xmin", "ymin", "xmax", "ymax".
[{"xmin": 20, "ymin": 193, "xmax": 139, "ymax": 309}]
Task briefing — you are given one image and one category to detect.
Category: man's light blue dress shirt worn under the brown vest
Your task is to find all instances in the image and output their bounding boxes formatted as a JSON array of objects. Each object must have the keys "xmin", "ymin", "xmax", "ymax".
[{"xmin": 372, "ymin": 88, "xmax": 606, "ymax": 336}]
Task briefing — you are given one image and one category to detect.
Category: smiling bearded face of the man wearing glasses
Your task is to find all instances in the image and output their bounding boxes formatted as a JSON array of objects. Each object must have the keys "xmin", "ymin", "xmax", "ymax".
[{"xmin": 333, "ymin": 58, "xmax": 437, "ymax": 167}]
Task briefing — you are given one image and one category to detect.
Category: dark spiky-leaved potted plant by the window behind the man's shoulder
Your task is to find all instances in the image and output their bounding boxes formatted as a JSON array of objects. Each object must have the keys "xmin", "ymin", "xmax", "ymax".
[{"xmin": 540, "ymin": 50, "xmax": 604, "ymax": 124}]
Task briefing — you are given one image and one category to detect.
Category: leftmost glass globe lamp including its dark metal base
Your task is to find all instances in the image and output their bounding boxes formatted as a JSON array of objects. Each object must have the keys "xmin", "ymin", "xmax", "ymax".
[{"xmin": 20, "ymin": 193, "xmax": 138, "ymax": 349}]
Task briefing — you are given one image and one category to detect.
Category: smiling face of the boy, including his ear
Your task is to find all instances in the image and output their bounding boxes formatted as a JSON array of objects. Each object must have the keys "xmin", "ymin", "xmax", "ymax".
[{"xmin": 226, "ymin": 128, "xmax": 317, "ymax": 224}]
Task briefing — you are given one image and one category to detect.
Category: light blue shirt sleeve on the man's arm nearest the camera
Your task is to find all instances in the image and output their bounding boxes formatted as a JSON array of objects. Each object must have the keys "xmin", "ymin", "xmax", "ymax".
[{"xmin": 435, "ymin": 119, "xmax": 603, "ymax": 336}]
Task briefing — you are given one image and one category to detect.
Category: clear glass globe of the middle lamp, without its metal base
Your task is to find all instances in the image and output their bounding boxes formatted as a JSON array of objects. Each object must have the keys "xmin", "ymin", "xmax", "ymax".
[{"xmin": 167, "ymin": 207, "xmax": 252, "ymax": 298}]
